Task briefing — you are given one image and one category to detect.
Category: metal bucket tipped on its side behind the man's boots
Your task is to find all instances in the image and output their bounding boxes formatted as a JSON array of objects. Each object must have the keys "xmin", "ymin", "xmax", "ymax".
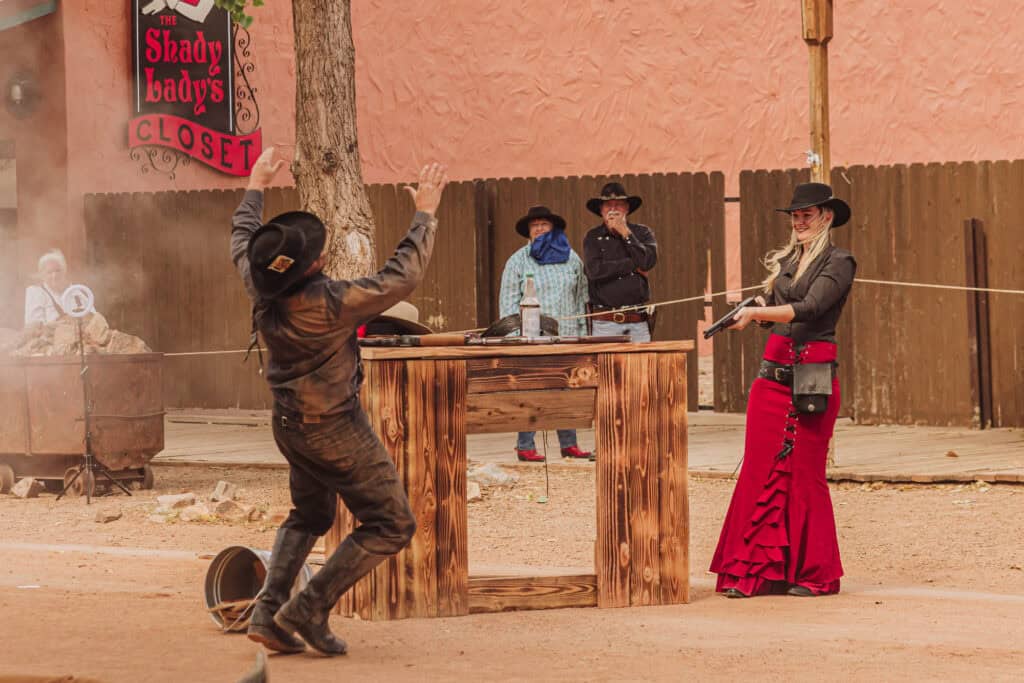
[{"xmin": 205, "ymin": 546, "xmax": 313, "ymax": 631}]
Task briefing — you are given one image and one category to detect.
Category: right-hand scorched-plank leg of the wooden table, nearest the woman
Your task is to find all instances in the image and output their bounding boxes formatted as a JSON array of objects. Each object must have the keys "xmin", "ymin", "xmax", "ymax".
[{"xmin": 595, "ymin": 353, "xmax": 689, "ymax": 607}]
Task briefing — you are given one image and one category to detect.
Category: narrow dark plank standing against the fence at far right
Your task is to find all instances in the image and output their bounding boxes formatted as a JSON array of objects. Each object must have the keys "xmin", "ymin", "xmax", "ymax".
[{"xmin": 964, "ymin": 218, "xmax": 993, "ymax": 429}]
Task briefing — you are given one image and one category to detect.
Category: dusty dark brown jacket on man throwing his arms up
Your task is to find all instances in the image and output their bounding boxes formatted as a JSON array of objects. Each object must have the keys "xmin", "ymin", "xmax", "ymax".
[{"xmin": 231, "ymin": 190, "xmax": 437, "ymax": 416}]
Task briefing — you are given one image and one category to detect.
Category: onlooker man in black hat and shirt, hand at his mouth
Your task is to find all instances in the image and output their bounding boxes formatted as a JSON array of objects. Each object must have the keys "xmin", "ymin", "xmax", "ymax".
[{"xmin": 583, "ymin": 182, "xmax": 657, "ymax": 341}]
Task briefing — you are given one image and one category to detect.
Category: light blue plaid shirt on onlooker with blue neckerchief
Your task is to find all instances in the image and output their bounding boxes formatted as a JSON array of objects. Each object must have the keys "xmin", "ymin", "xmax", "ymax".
[{"xmin": 498, "ymin": 243, "xmax": 587, "ymax": 337}]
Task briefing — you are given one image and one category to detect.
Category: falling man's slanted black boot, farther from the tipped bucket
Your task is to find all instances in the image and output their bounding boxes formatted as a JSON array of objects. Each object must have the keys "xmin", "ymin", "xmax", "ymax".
[{"xmin": 273, "ymin": 539, "xmax": 387, "ymax": 654}]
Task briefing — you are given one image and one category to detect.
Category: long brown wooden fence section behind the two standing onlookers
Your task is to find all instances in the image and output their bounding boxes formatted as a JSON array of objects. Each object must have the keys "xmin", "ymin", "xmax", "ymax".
[{"xmin": 85, "ymin": 173, "xmax": 725, "ymax": 409}]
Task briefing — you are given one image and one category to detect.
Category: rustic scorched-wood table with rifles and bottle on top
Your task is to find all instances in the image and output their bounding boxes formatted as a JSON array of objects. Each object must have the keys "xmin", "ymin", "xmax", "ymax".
[{"xmin": 326, "ymin": 341, "xmax": 694, "ymax": 620}]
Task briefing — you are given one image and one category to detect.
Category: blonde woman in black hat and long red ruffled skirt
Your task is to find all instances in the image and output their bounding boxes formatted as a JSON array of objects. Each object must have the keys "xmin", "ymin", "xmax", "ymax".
[{"xmin": 711, "ymin": 182, "xmax": 857, "ymax": 598}]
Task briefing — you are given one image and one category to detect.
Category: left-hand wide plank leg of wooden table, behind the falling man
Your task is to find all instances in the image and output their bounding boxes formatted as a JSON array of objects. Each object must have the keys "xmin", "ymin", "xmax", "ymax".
[{"xmin": 326, "ymin": 359, "xmax": 469, "ymax": 620}]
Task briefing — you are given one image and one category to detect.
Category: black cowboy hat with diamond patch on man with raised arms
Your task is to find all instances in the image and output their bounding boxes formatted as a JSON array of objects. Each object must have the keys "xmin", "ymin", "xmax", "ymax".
[{"xmin": 248, "ymin": 211, "xmax": 327, "ymax": 299}]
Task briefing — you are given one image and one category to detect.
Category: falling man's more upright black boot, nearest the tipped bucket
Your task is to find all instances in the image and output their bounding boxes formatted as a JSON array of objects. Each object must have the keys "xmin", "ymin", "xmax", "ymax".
[{"xmin": 247, "ymin": 527, "xmax": 316, "ymax": 654}]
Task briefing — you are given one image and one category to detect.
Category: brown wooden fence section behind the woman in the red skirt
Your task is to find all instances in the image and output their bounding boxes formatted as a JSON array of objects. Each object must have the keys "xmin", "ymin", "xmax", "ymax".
[{"xmin": 715, "ymin": 161, "xmax": 1024, "ymax": 427}]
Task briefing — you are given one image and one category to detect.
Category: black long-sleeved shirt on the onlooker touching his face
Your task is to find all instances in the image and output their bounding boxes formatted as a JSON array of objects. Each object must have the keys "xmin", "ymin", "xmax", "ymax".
[{"xmin": 583, "ymin": 223, "xmax": 657, "ymax": 308}]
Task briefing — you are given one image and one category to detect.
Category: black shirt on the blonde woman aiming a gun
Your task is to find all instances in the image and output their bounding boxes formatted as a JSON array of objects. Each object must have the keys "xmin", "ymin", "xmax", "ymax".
[{"xmin": 768, "ymin": 246, "xmax": 857, "ymax": 344}]
